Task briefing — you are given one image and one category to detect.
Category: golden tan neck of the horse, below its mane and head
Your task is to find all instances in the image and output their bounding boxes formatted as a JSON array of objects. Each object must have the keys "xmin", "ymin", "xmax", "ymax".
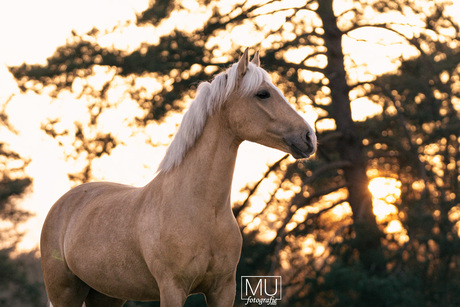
[{"xmin": 155, "ymin": 113, "xmax": 240, "ymax": 212}]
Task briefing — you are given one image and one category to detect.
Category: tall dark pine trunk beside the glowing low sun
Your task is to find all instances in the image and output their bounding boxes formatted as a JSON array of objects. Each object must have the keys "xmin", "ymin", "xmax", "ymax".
[{"xmin": 317, "ymin": 0, "xmax": 384, "ymax": 271}]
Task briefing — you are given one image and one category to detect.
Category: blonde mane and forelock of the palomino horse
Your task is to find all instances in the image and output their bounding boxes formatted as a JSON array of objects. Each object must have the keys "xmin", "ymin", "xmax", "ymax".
[{"xmin": 158, "ymin": 63, "xmax": 270, "ymax": 172}]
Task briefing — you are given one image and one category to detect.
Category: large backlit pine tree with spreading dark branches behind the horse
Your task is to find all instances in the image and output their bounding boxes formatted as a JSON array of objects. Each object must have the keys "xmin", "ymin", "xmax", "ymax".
[{"xmin": 10, "ymin": 0, "xmax": 460, "ymax": 306}]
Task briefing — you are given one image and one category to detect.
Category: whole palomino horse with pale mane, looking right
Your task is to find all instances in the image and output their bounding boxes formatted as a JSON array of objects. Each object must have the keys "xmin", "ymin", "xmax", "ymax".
[{"xmin": 41, "ymin": 50, "xmax": 316, "ymax": 307}]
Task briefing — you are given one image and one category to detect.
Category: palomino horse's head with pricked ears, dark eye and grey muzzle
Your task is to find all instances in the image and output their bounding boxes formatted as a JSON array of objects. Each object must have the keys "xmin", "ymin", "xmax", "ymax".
[{"xmin": 224, "ymin": 50, "xmax": 316, "ymax": 159}]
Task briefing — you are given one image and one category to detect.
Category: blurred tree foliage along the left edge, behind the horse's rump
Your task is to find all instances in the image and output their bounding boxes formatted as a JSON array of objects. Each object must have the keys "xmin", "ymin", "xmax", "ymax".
[{"xmin": 0, "ymin": 108, "xmax": 44, "ymax": 306}]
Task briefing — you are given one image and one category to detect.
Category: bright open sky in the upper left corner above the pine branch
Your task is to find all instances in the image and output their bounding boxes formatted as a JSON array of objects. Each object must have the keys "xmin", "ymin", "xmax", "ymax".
[{"xmin": 0, "ymin": 0, "xmax": 148, "ymax": 65}]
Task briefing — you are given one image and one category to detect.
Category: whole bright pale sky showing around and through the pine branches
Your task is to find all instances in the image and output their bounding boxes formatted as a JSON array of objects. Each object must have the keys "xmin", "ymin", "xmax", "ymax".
[{"xmin": 0, "ymin": 0, "xmax": 460, "ymax": 253}]
